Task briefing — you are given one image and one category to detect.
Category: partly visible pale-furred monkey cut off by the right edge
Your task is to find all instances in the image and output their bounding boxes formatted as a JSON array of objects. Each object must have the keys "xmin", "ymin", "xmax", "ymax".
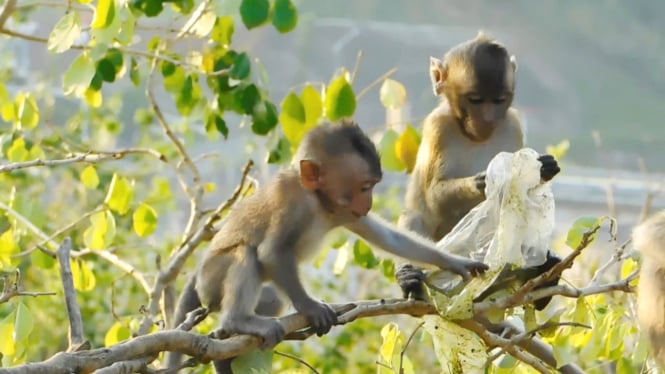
[{"xmin": 633, "ymin": 210, "xmax": 665, "ymax": 370}]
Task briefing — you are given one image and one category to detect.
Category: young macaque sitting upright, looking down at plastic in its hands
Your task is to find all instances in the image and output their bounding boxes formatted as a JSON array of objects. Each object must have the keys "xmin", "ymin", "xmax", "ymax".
[{"xmin": 397, "ymin": 32, "xmax": 560, "ymax": 306}]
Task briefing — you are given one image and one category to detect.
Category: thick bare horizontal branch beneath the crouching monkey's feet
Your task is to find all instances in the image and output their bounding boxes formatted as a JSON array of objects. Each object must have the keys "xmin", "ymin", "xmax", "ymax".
[{"xmin": 6, "ymin": 299, "xmax": 579, "ymax": 374}]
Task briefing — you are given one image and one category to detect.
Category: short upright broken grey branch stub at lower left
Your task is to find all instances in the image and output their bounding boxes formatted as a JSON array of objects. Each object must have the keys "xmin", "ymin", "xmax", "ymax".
[{"xmin": 56, "ymin": 237, "xmax": 85, "ymax": 350}]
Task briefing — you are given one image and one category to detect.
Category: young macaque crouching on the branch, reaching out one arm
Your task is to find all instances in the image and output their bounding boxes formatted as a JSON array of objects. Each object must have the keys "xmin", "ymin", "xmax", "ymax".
[{"xmin": 169, "ymin": 121, "xmax": 487, "ymax": 371}]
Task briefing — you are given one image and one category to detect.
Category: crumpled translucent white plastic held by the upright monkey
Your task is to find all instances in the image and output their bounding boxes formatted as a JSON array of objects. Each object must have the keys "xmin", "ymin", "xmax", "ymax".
[{"xmin": 437, "ymin": 148, "xmax": 554, "ymax": 269}]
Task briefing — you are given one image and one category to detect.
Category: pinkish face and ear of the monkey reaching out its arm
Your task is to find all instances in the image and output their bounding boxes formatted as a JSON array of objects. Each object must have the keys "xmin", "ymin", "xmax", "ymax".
[{"xmin": 319, "ymin": 155, "xmax": 379, "ymax": 222}]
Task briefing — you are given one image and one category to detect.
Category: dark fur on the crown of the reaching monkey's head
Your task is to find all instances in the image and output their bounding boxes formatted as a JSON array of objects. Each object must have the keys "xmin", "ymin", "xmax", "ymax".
[{"xmin": 293, "ymin": 119, "xmax": 383, "ymax": 179}]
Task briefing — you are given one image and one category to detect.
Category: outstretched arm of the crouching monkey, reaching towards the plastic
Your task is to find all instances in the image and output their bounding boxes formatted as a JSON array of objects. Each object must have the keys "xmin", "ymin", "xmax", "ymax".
[{"xmin": 346, "ymin": 213, "xmax": 488, "ymax": 280}]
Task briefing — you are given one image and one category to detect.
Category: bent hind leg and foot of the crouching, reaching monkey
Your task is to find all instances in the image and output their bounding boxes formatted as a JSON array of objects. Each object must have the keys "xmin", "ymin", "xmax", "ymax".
[{"xmin": 215, "ymin": 254, "xmax": 285, "ymax": 348}]
